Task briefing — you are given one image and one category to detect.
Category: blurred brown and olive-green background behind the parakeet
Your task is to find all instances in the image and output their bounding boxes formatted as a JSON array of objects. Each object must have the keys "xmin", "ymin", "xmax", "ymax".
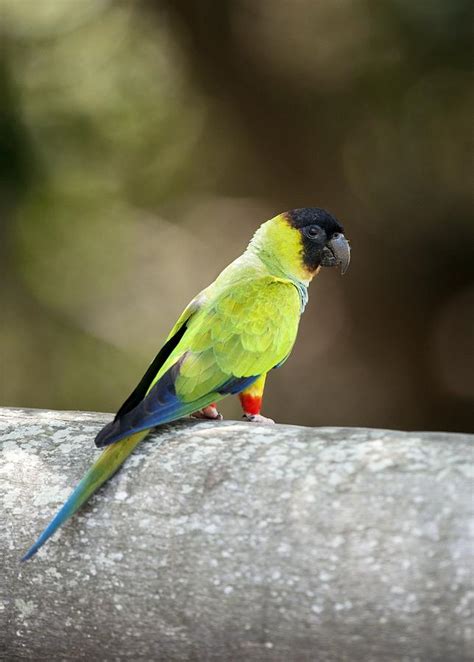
[{"xmin": 0, "ymin": 0, "xmax": 474, "ymax": 431}]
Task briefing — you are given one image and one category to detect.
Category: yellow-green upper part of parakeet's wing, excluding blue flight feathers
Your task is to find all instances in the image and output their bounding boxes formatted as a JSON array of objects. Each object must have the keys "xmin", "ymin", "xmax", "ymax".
[{"xmin": 152, "ymin": 276, "xmax": 300, "ymax": 402}]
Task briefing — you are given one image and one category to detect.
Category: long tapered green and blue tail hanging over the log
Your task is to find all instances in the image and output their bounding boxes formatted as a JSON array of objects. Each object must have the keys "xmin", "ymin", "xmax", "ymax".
[{"xmin": 21, "ymin": 430, "xmax": 150, "ymax": 561}]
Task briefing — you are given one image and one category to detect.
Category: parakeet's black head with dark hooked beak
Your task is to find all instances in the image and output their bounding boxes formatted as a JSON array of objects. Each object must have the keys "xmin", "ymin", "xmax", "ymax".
[{"xmin": 286, "ymin": 207, "xmax": 351, "ymax": 273}]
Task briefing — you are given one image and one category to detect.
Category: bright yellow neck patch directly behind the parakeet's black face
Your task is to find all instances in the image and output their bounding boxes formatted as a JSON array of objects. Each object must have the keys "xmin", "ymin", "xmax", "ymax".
[{"xmin": 246, "ymin": 217, "xmax": 313, "ymax": 312}]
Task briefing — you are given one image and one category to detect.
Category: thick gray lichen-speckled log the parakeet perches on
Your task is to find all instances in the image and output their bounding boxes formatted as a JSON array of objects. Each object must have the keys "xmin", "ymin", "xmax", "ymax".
[{"xmin": 0, "ymin": 409, "xmax": 473, "ymax": 662}]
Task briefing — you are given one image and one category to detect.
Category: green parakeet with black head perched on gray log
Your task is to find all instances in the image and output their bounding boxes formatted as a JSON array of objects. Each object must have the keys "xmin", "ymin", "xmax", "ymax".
[{"xmin": 22, "ymin": 207, "xmax": 350, "ymax": 560}]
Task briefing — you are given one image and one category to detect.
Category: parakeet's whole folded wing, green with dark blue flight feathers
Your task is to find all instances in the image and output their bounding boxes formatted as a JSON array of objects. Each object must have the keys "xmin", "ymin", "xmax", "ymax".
[{"xmin": 96, "ymin": 277, "xmax": 300, "ymax": 446}]
